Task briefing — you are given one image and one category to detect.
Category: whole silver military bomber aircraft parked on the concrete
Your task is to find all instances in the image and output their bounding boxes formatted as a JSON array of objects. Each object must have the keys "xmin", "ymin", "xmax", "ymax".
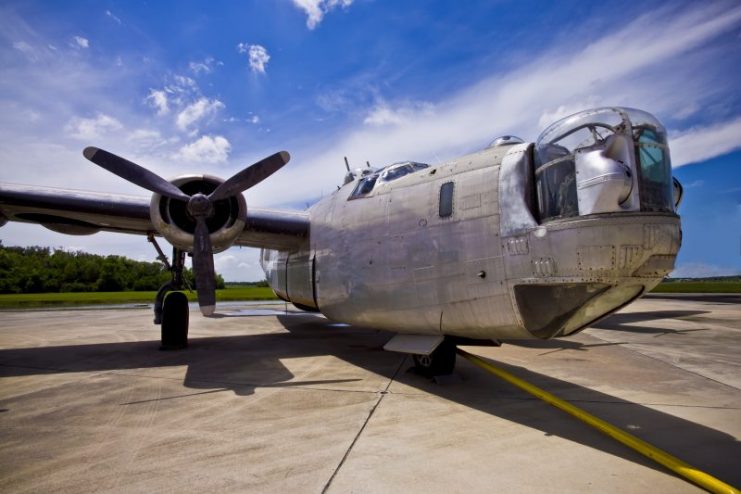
[{"xmin": 0, "ymin": 107, "xmax": 682, "ymax": 375}]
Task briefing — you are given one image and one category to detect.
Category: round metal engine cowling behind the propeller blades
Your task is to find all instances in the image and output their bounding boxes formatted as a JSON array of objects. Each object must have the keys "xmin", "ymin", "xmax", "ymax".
[{"xmin": 149, "ymin": 175, "xmax": 247, "ymax": 253}]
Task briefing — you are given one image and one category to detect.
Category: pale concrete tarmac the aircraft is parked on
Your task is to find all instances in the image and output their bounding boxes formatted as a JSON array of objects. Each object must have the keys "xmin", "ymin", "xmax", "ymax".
[{"xmin": 0, "ymin": 296, "xmax": 741, "ymax": 493}]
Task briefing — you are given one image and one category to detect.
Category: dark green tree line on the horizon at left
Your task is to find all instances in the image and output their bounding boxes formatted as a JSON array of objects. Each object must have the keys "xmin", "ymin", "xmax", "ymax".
[{"xmin": 0, "ymin": 244, "xmax": 224, "ymax": 293}]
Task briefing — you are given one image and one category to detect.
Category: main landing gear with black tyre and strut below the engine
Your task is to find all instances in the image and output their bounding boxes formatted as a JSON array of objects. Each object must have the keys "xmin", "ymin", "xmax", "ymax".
[{"xmin": 147, "ymin": 234, "xmax": 190, "ymax": 350}]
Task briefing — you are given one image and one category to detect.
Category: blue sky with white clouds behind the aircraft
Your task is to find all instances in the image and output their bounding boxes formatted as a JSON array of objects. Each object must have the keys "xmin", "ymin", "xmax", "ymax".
[{"xmin": 0, "ymin": 0, "xmax": 741, "ymax": 280}]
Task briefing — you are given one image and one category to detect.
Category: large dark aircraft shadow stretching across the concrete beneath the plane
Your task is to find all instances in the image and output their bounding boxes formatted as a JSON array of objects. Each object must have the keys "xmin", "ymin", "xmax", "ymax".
[{"xmin": 0, "ymin": 315, "xmax": 741, "ymax": 485}]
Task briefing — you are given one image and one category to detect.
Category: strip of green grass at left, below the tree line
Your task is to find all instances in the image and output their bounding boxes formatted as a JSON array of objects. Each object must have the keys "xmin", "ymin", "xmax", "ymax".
[{"xmin": 0, "ymin": 286, "xmax": 278, "ymax": 309}]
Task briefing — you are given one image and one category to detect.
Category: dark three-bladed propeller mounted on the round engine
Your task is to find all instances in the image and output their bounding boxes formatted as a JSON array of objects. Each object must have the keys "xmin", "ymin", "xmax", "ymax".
[{"xmin": 82, "ymin": 147, "xmax": 291, "ymax": 316}]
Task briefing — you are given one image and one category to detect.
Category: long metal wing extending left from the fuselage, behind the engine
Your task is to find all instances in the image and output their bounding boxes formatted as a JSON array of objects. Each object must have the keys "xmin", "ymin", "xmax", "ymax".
[{"xmin": 0, "ymin": 184, "xmax": 309, "ymax": 250}]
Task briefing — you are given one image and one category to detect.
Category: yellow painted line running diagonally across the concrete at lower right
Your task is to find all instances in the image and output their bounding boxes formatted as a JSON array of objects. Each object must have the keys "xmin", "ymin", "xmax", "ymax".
[{"xmin": 458, "ymin": 349, "xmax": 741, "ymax": 494}]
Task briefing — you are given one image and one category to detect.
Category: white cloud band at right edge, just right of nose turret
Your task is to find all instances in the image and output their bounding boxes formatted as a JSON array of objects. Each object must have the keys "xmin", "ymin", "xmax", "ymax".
[{"xmin": 669, "ymin": 117, "xmax": 741, "ymax": 168}]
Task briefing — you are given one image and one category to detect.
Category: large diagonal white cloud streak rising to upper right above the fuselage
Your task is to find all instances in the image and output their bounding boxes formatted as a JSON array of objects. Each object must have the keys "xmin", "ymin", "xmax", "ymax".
[{"xmin": 246, "ymin": 4, "xmax": 741, "ymax": 206}]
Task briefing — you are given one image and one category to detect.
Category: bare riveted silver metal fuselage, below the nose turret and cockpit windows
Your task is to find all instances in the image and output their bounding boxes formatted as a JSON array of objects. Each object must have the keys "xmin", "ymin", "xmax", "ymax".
[{"xmin": 262, "ymin": 139, "xmax": 681, "ymax": 340}]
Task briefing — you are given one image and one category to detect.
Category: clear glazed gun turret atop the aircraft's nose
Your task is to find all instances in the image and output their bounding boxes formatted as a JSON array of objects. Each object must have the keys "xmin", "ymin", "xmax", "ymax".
[{"xmin": 535, "ymin": 107, "xmax": 678, "ymax": 221}]
